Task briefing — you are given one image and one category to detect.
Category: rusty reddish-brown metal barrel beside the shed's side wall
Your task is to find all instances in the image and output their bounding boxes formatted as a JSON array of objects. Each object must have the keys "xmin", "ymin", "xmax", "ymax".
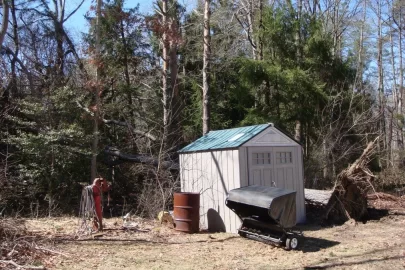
[{"xmin": 173, "ymin": 192, "xmax": 200, "ymax": 233}]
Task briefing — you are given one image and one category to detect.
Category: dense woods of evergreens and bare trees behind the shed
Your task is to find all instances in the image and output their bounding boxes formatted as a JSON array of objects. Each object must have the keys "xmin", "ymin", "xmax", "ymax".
[{"xmin": 0, "ymin": 0, "xmax": 405, "ymax": 217}]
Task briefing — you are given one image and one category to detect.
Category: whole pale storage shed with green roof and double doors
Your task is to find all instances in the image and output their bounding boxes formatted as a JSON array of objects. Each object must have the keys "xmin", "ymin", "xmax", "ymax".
[{"xmin": 179, "ymin": 124, "xmax": 305, "ymax": 233}]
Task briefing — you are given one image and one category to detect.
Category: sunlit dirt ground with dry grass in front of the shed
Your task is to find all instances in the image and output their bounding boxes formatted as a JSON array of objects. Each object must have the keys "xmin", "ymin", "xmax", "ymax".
[{"xmin": 18, "ymin": 211, "xmax": 405, "ymax": 270}]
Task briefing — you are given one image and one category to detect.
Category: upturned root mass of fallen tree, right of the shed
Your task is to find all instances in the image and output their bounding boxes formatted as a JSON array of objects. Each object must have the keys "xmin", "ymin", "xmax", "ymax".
[{"xmin": 325, "ymin": 137, "xmax": 379, "ymax": 222}]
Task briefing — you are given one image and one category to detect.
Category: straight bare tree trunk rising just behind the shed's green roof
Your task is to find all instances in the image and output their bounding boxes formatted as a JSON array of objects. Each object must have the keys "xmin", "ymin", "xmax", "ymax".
[{"xmin": 203, "ymin": 0, "xmax": 211, "ymax": 135}]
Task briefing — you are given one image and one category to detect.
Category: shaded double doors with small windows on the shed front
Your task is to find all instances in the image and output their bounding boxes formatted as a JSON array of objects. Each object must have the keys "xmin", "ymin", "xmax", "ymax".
[{"xmin": 248, "ymin": 147, "xmax": 297, "ymax": 190}]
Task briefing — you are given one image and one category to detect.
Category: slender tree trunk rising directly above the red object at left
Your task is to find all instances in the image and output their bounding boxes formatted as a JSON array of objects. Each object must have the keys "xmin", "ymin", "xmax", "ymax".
[{"xmin": 90, "ymin": 0, "xmax": 103, "ymax": 182}]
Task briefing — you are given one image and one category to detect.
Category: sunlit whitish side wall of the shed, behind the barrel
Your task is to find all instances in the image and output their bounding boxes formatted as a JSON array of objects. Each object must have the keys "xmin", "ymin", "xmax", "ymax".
[{"xmin": 180, "ymin": 150, "xmax": 241, "ymax": 233}]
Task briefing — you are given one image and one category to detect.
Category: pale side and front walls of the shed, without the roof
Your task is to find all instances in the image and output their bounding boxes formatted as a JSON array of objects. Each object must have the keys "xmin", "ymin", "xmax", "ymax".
[{"xmin": 180, "ymin": 126, "xmax": 306, "ymax": 233}]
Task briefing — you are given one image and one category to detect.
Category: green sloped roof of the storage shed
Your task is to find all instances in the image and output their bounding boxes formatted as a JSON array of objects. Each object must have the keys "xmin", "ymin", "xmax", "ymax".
[{"xmin": 179, "ymin": 124, "xmax": 271, "ymax": 153}]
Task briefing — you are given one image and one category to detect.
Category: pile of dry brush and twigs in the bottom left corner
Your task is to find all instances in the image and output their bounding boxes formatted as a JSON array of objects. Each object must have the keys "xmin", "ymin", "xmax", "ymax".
[{"xmin": 0, "ymin": 219, "xmax": 64, "ymax": 269}]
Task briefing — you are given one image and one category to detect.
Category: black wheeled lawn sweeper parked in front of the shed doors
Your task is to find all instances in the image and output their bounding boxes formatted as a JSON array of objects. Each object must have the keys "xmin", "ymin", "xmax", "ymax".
[{"xmin": 225, "ymin": 186, "xmax": 298, "ymax": 250}]
